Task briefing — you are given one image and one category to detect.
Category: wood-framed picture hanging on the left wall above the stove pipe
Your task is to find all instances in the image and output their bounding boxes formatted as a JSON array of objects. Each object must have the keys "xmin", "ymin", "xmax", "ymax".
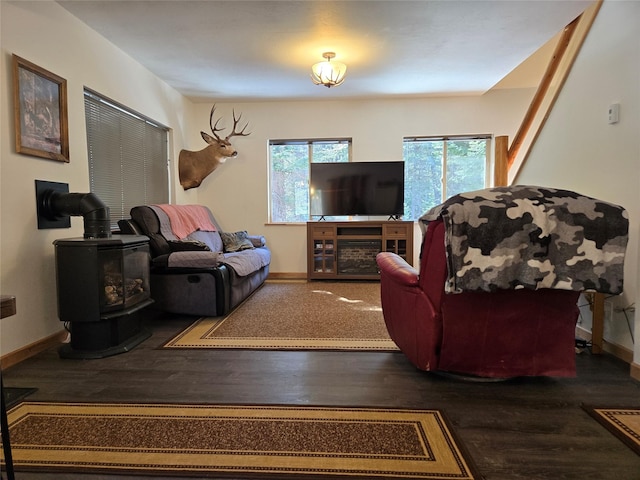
[{"xmin": 13, "ymin": 54, "xmax": 69, "ymax": 163}]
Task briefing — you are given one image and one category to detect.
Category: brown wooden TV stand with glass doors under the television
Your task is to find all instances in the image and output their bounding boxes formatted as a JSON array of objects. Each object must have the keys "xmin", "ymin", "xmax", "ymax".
[{"xmin": 307, "ymin": 220, "xmax": 414, "ymax": 280}]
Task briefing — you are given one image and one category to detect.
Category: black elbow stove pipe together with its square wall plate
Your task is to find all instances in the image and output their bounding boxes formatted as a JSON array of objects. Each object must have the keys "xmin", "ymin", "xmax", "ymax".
[{"xmin": 36, "ymin": 182, "xmax": 111, "ymax": 238}]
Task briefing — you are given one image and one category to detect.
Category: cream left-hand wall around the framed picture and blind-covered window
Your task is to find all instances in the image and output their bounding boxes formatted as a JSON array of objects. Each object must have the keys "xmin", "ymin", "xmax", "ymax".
[{"xmin": 0, "ymin": 0, "xmax": 192, "ymax": 354}]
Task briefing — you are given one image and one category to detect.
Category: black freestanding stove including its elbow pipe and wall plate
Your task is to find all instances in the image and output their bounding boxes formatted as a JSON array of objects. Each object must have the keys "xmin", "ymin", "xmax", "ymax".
[{"xmin": 36, "ymin": 181, "xmax": 153, "ymax": 358}]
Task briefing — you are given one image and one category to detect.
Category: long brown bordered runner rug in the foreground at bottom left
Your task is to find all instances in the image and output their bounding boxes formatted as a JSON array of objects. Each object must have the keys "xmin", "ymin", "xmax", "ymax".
[{"xmin": 3, "ymin": 402, "xmax": 480, "ymax": 480}]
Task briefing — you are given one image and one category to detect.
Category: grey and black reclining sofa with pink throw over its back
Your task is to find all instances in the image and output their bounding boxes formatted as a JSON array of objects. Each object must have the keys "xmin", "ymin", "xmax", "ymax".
[{"xmin": 119, "ymin": 205, "xmax": 271, "ymax": 317}]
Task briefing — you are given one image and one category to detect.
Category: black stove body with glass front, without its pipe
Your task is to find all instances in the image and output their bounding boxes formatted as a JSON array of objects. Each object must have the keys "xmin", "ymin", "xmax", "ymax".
[{"xmin": 53, "ymin": 235, "xmax": 153, "ymax": 358}]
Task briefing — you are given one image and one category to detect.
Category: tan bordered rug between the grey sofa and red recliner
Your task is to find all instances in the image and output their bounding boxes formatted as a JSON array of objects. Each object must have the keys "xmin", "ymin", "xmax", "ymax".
[{"xmin": 164, "ymin": 282, "xmax": 398, "ymax": 351}]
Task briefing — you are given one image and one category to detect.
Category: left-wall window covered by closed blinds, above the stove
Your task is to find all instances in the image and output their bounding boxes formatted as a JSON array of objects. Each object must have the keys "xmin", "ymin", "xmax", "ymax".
[{"xmin": 84, "ymin": 90, "xmax": 169, "ymax": 229}]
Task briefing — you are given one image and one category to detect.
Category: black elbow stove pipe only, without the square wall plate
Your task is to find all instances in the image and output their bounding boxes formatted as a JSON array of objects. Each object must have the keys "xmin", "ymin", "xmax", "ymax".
[{"xmin": 40, "ymin": 190, "xmax": 111, "ymax": 238}]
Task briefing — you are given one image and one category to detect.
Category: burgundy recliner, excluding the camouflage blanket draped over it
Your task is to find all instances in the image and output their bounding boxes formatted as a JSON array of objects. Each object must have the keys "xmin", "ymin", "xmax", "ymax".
[{"xmin": 376, "ymin": 186, "xmax": 626, "ymax": 378}]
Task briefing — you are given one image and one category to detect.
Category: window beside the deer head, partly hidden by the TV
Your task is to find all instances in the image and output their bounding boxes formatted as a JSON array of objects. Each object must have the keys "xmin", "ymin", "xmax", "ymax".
[{"xmin": 269, "ymin": 138, "xmax": 351, "ymax": 222}]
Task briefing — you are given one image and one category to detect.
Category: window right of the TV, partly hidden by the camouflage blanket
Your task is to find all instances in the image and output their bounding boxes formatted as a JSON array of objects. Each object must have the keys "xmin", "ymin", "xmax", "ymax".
[{"xmin": 402, "ymin": 136, "xmax": 490, "ymax": 220}]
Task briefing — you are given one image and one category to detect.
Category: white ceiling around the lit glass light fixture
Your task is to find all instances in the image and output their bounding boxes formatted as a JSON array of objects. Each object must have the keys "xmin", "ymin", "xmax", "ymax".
[{"xmin": 58, "ymin": 0, "xmax": 594, "ymax": 101}]
